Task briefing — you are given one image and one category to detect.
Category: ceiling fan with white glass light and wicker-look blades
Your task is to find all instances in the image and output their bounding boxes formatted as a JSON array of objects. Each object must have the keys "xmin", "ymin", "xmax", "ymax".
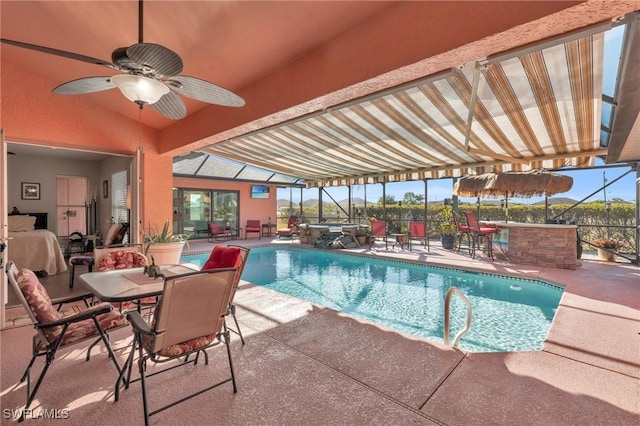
[{"xmin": 0, "ymin": 0, "xmax": 244, "ymax": 120}]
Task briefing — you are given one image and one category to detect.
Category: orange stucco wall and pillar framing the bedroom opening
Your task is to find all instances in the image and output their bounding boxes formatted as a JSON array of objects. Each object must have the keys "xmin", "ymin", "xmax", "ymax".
[{"xmin": 0, "ymin": 62, "xmax": 173, "ymax": 231}]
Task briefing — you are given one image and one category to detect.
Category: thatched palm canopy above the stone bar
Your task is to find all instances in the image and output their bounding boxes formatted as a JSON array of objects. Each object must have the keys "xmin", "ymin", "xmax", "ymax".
[{"xmin": 453, "ymin": 170, "xmax": 573, "ymax": 220}]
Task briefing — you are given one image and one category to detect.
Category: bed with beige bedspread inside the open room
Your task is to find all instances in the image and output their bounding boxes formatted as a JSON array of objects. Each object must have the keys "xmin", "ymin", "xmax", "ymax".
[{"xmin": 8, "ymin": 215, "xmax": 67, "ymax": 275}]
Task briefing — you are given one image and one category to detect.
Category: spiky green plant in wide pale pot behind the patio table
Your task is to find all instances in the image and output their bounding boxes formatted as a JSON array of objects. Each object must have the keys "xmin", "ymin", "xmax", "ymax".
[{"xmin": 142, "ymin": 221, "xmax": 191, "ymax": 265}]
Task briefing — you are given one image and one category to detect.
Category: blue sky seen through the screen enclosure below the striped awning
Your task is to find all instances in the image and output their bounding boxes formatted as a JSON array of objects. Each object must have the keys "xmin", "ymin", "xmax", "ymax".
[{"xmin": 277, "ymin": 159, "xmax": 636, "ymax": 204}]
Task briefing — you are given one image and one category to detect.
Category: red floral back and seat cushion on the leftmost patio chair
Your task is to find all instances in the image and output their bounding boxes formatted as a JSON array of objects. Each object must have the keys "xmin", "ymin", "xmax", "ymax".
[{"xmin": 17, "ymin": 269, "xmax": 126, "ymax": 350}]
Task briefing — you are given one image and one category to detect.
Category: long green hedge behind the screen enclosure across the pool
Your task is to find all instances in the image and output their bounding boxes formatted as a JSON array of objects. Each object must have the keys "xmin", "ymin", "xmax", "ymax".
[{"xmin": 278, "ymin": 202, "xmax": 636, "ymax": 253}]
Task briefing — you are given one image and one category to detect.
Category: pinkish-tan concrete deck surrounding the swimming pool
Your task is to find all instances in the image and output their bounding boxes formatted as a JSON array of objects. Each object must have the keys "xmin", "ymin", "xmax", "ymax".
[{"xmin": 1, "ymin": 238, "xmax": 640, "ymax": 425}]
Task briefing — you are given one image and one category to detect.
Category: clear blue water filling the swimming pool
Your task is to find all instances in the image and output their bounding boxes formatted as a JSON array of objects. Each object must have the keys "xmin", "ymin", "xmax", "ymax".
[{"xmin": 182, "ymin": 247, "xmax": 562, "ymax": 352}]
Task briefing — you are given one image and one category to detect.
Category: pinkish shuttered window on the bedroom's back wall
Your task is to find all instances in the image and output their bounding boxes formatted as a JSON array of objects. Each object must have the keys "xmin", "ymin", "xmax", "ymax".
[{"xmin": 56, "ymin": 176, "xmax": 89, "ymax": 236}]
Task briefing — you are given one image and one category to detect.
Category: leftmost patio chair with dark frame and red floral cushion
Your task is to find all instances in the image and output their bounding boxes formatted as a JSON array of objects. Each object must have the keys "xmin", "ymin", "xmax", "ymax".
[{"xmin": 7, "ymin": 261, "xmax": 126, "ymax": 421}]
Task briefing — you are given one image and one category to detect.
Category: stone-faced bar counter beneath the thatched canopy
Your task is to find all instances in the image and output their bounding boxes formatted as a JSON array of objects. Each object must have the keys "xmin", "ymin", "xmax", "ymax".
[{"xmin": 482, "ymin": 221, "xmax": 578, "ymax": 269}]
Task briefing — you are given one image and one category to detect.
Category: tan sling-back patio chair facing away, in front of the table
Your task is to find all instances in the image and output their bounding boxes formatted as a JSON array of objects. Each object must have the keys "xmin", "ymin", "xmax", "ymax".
[{"xmin": 115, "ymin": 268, "xmax": 237, "ymax": 425}]
